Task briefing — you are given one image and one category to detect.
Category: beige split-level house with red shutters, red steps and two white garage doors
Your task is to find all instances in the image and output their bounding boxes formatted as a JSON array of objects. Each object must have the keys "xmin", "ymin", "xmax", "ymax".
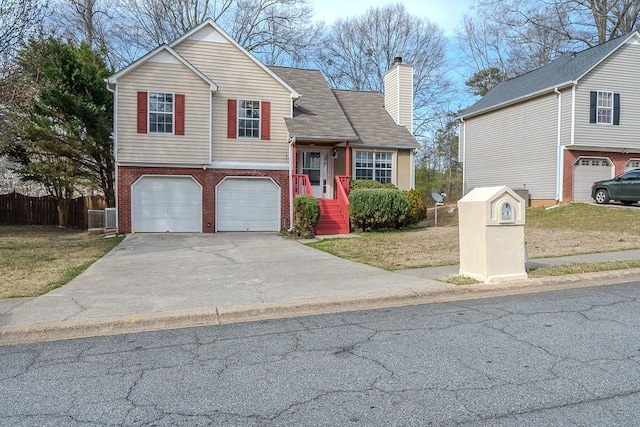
[{"xmin": 107, "ymin": 20, "xmax": 418, "ymax": 234}]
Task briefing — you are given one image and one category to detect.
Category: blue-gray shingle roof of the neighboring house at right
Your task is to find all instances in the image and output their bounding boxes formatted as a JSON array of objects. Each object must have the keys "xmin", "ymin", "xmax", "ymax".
[{"xmin": 459, "ymin": 33, "xmax": 638, "ymax": 118}]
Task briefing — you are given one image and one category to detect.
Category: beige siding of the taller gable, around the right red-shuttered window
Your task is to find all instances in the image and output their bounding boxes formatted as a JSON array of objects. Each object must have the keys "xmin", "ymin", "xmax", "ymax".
[{"xmin": 174, "ymin": 37, "xmax": 292, "ymax": 163}]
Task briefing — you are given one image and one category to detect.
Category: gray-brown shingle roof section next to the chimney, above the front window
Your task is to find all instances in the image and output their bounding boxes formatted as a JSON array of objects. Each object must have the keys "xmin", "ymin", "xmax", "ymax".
[{"xmin": 333, "ymin": 89, "xmax": 418, "ymax": 148}]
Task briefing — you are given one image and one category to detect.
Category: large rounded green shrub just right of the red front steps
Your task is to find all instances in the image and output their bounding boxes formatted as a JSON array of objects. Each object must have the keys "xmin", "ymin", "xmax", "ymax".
[{"xmin": 349, "ymin": 188, "xmax": 409, "ymax": 231}]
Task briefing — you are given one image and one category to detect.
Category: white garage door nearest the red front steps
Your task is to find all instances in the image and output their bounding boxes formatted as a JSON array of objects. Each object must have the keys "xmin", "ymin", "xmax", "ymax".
[{"xmin": 216, "ymin": 178, "xmax": 280, "ymax": 231}]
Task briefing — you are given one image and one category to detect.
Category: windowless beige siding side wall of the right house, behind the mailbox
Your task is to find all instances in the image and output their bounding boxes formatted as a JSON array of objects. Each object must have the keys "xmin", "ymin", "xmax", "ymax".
[{"xmin": 464, "ymin": 93, "xmax": 558, "ymax": 199}]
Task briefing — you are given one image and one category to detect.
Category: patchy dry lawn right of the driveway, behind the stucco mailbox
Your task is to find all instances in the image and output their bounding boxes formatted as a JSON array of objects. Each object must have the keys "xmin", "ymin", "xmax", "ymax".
[{"xmin": 310, "ymin": 203, "xmax": 640, "ymax": 270}]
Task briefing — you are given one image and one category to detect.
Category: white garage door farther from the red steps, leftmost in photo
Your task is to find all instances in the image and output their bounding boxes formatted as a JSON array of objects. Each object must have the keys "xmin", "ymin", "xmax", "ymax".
[{"xmin": 131, "ymin": 176, "xmax": 202, "ymax": 233}]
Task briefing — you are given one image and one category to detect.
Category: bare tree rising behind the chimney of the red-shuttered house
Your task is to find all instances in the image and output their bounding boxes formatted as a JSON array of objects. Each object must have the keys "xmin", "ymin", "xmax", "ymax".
[{"xmin": 317, "ymin": 4, "xmax": 449, "ymax": 134}]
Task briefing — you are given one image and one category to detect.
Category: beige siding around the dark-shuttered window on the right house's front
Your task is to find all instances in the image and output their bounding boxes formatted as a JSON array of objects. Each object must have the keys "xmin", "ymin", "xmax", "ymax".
[{"xmin": 574, "ymin": 39, "xmax": 640, "ymax": 149}]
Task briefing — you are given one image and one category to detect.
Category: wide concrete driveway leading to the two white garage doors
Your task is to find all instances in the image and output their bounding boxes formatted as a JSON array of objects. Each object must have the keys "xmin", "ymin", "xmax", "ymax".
[{"xmin": 0, "ymin": 233, "xmax": 451, "ymax": 326}]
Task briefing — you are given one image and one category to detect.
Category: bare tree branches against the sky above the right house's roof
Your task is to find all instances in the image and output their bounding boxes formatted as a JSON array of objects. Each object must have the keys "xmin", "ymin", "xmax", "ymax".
[{"xmin": 458, "ymin": 0, "xmax": 640, "ymax": 84}]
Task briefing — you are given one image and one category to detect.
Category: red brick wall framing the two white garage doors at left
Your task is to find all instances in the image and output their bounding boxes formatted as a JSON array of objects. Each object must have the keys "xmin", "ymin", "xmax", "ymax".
[{"xmin": 117, "ymin": 166, "xmax": 290, "ymax": 233}]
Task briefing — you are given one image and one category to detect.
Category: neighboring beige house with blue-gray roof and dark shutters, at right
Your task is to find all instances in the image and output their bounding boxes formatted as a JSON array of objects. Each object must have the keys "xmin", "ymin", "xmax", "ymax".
[{"xmin": 459, "ymin": 32, "xmax": 640, "ymax": 205}]
